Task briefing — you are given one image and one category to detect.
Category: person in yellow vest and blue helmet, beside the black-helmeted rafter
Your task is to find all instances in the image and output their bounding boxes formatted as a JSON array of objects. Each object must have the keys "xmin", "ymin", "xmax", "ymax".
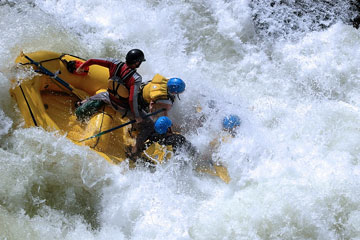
[{"xmin": 139, "ymin": 74, "xmax": 186, "ymax": 120}]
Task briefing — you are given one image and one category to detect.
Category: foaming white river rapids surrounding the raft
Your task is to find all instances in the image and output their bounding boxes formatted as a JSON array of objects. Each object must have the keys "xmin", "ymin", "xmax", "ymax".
[{"xmin": 0, "ymin": 0, "xmax": 360, "ymax": 240}]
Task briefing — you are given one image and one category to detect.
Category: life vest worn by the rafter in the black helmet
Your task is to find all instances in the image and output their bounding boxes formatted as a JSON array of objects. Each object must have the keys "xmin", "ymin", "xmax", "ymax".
[{"xmin": 108, "ymin": 62, "xmax": 136, "ymax": 101}]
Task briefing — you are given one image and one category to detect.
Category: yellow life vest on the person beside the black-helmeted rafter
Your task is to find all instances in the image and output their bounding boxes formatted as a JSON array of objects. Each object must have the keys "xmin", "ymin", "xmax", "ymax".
[{"xmin": 142, "ymin": 74, "xmax": 175, "ymax": 104}]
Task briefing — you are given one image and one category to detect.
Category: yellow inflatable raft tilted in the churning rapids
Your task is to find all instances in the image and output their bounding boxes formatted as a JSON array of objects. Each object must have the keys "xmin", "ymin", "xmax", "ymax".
[{"xmin": 10, "ymin": 51, "xmax": 231, "ymax": 183}]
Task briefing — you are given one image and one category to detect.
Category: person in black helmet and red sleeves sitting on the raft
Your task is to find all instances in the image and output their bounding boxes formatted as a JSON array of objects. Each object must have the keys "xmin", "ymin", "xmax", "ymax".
[{"xmin": 75, "ymin": 49, "xmax": 154, "ymax": 159}]
